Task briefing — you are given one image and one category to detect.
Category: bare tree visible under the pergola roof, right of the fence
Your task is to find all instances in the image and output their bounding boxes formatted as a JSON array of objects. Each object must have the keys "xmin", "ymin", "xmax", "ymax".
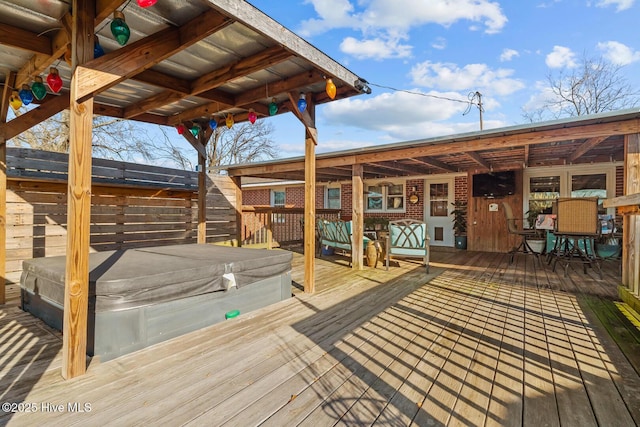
[{"xmin": 207, "ymin": 120, "xmax": 277, "ymax": 172}]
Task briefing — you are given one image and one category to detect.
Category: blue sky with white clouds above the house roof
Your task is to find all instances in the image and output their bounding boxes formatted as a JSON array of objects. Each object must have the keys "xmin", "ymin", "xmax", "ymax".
[{"xmin": 242, "ymin": 0, "xmax": 640, "ymax": 157}]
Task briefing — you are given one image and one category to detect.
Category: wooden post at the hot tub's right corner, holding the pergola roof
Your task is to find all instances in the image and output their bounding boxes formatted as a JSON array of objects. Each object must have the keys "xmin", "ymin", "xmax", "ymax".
[{"xmin": 304, "ymin": 100, "xmax": 318, "ymax": 293}]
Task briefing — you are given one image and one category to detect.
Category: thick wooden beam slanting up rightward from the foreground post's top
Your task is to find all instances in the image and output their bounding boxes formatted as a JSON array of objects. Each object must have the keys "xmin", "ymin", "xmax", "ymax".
[{"xmin": 76, "ymin": 10, "xmax": 231, "ymax": 102}]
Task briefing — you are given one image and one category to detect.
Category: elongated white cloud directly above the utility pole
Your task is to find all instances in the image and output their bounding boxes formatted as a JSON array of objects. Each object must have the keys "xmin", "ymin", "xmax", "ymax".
[{"xmin": 411, "ymin": 61, "xmax": 524, "ymax": 95}]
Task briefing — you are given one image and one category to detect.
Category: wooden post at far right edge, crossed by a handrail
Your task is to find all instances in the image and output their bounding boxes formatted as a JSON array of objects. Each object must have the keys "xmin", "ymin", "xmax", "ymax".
[{"xmin": 622, "ymin": 134, "xmax": 640, "ymax": 296}]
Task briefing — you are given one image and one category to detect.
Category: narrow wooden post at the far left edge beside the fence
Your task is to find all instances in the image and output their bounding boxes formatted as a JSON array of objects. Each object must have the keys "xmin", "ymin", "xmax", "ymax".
[{"xmin": 0, "ymin": 72, "xmax": 16, "ymax": 304}]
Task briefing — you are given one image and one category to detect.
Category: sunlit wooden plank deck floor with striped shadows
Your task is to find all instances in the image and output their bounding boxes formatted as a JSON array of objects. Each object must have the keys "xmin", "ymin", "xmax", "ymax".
[{"xmin": 0, "ymin": 251, "xmax": 640, "ymax": 427}]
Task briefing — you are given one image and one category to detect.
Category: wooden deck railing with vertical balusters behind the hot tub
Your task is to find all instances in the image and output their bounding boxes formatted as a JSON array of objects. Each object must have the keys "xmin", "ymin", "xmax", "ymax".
[{"xmin": 242, "ymin": 206, "xmax": 340, "ymax": 249}]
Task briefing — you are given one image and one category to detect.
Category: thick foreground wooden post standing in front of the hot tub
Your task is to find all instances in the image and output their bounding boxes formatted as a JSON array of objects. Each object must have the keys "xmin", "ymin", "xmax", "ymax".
[{"xmin": 62, "ymin": 0, "xmax": 95, "ymax": 379}]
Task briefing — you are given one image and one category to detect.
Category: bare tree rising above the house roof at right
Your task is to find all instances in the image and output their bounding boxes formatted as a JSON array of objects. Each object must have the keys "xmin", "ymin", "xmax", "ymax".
[{"xmin": 523, "ymin": 55, "xmax": 640, "ymax": 122}]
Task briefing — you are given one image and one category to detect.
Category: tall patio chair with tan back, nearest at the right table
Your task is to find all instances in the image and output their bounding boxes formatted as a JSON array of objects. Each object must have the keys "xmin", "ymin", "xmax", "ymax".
[{"xmin": 551, "ymin": 197, "xmax": 602, "ymax": 276}]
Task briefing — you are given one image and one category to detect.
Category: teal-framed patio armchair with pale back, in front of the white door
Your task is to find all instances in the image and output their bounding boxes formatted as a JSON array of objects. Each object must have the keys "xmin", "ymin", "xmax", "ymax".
[{"xmin": 385, "ymin": 219, "xmax": 430, "ymax": 273}]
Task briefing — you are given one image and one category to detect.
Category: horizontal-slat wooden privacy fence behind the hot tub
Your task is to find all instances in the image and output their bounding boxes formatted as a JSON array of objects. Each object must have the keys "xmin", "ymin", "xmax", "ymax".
[{"xmin": 5, "ymin": 148, "xmax": 236, "ymax": 282}]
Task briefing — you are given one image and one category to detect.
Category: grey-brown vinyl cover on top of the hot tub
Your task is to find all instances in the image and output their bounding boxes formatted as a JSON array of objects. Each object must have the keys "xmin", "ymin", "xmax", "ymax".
[{"xmin": 20, "ymin": 244, "xmax": 292, "ymax": 312}]
